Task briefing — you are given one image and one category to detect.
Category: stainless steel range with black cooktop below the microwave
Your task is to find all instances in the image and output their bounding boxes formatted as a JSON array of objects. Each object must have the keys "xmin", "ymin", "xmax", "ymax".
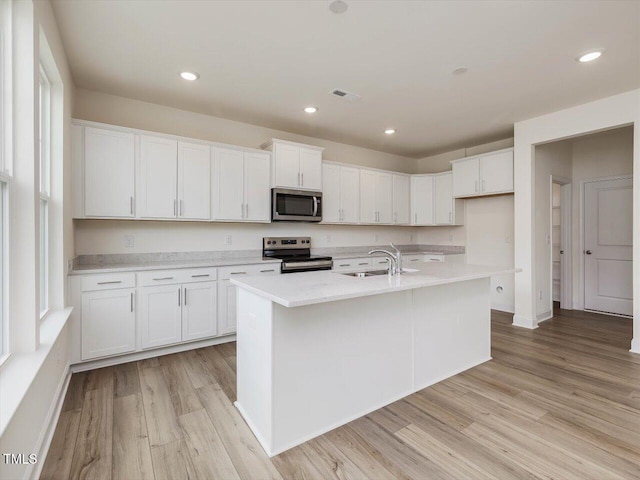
[{"xmin": 262, "ymin": 237, "xmax": 333, "ymax": 273}]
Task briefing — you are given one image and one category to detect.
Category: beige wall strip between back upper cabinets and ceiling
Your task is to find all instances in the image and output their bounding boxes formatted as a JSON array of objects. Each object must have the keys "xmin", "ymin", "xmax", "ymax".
[{"xmin": 73, "ymin": 88, "xmax": 416, "ymax": 173}]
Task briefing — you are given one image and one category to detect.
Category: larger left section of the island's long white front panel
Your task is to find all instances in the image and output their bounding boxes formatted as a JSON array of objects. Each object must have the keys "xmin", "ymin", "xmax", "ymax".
[{"xmin": 268, "ymin": 291, "xmax": 413, "ymax": 454}]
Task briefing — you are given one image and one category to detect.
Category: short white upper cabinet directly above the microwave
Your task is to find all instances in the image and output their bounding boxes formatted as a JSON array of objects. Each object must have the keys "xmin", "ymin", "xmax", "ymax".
[{"xmin": 261, "ymin": 139, "xmax": 323, "ymax": 191}]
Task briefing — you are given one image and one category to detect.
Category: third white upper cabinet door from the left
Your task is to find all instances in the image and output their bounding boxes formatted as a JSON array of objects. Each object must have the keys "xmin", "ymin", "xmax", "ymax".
[{"xmin": 178, "ymin": 142, "xmax": 211, "ymax": 220}]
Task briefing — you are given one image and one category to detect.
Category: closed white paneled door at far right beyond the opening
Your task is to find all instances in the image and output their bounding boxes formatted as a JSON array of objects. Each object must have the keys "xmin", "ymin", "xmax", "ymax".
[{"xmin": 584, "ymin": 178, "xmax": 633, "ymax": 315}]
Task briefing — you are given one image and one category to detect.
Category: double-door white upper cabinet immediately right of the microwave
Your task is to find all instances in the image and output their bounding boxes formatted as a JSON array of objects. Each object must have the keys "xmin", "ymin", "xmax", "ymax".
[{"xmin": 322, "ymin": 163, "xmax": 360, "ymax": 224}]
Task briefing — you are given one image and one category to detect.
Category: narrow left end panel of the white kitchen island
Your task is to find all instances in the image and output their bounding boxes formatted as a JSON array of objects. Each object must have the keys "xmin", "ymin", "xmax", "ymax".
[{"xmin": 235, "ymin": 288, "xmax": 273, "ymax": 455}]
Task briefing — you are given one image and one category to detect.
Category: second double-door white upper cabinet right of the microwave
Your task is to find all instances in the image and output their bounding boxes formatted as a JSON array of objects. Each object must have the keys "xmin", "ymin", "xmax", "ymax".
[{"xmin": 360, "ymin": 169, "xmax": 393, "ymax": 224}]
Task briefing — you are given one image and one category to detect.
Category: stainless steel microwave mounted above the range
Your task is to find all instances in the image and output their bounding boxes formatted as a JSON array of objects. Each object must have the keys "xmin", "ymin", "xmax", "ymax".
[{"xmin": 271, "ymin": 188, "xmax": 322, "ymax": 222}]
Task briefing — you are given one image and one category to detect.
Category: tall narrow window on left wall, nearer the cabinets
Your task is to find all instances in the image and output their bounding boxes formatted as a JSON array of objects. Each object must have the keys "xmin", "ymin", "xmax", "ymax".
[{"xmin": 39, "ymin": 66, "xmax": 51, "ymax": 318}]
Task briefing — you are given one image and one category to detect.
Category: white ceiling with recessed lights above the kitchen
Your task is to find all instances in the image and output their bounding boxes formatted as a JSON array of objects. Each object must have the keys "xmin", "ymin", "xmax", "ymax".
[{"xmin": 53, "ymin": 0, "xmax": 640, "ymax": 158}]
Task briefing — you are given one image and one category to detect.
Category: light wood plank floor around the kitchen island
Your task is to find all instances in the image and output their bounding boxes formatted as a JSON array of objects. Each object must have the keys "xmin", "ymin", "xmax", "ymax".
[{"xmin": 42, "ymin": 311, "xmax": 640, "ymax": 480}]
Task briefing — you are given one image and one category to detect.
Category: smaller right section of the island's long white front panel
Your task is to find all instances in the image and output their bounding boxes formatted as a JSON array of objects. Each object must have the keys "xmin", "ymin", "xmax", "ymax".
[{"xmin": 413, "ymin": 278, "xmax": 491, "ymax": 390}]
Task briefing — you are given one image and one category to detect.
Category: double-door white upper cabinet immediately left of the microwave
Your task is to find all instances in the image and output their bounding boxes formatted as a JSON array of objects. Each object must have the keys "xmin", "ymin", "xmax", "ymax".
[{"xmin": 211, "ymin": 148, "xmax": 271, "ymax": 222}]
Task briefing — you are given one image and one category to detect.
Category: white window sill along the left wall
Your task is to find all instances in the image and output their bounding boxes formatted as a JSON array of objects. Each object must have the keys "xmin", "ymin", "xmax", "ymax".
[{"xmin": 0, "ymin": 307, "xmax": 73, "ymax": 436}]
